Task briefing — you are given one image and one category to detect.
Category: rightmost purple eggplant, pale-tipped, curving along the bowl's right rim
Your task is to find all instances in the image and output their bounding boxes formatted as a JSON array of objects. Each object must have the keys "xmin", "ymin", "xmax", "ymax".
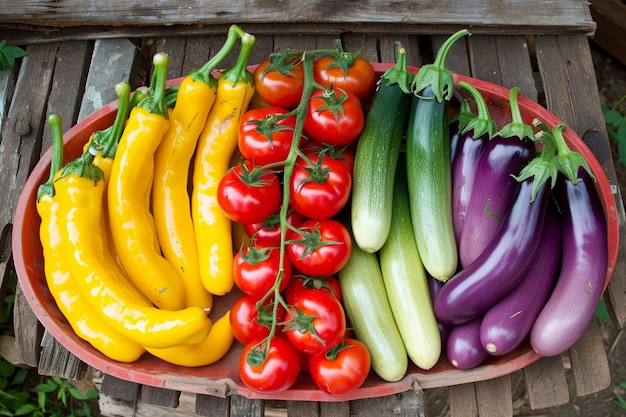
[{"xmin": 530, "ymin": 149, "xmax": 608, "ymax": 356}]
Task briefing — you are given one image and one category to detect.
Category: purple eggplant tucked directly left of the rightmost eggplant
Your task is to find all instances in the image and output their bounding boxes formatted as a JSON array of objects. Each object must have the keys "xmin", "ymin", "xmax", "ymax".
[{"xmin": 480, "ymin": 204, "xmax": 563, "ymax": 355}]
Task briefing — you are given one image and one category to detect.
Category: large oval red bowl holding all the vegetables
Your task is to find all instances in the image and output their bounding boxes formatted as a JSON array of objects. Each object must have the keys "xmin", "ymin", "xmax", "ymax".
[{"xmin": 13, "ymin": 64, "xmax": 618, "ymax": 401}]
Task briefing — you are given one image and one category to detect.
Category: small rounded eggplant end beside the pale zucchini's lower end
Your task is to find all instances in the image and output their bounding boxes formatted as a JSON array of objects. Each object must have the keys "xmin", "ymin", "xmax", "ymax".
[{"xmin": 446, "ymin": 317, "xmax": 489, "ymax": 369}]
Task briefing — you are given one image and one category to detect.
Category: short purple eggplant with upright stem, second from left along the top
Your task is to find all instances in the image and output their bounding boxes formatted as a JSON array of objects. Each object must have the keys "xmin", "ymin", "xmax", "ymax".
[{"xmin": 458, "ymin": 88, "xmax": 535, "ymax": 267}]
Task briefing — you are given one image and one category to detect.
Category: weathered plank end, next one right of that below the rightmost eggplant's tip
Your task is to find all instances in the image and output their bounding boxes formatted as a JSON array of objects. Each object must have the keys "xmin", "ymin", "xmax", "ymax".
[{"xmin": 569, "ymin": 318, "xmax": 611, "ymax": 397}]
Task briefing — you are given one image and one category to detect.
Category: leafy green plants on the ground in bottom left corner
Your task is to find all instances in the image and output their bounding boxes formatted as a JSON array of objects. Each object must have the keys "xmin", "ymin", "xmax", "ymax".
[{"xmin": 0, "ymin": 272, "xmax": 99, "ymax": 417}]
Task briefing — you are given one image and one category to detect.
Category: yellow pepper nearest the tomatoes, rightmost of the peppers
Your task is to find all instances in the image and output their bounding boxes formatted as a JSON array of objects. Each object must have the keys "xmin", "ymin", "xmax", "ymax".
[{"xmin": 191, "ymin": 33, "xmax": 255, "ymax": 295}]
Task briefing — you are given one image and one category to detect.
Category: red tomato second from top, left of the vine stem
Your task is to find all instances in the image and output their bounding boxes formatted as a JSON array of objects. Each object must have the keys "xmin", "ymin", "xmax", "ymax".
[{"xmin": 237, "ymin": 107, "xmax": 296, "ymax": 165}]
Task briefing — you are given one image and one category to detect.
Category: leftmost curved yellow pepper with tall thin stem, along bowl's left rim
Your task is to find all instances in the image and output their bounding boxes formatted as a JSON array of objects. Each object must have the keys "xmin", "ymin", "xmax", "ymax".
[{"xmin": 37, "ymin": 115, "xmax": 145, "ymax": 362}]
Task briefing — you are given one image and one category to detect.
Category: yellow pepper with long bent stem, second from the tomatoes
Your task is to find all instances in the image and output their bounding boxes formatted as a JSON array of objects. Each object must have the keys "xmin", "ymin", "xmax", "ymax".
[{"xmin": 152, "ymin": 26, "xmax": 238, "ymax": 309}]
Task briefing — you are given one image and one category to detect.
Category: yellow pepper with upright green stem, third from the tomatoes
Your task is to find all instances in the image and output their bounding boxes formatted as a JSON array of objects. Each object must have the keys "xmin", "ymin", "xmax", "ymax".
[{"xmin": 107, "ymin": 53, "xmax": 186, "ymax": 310}]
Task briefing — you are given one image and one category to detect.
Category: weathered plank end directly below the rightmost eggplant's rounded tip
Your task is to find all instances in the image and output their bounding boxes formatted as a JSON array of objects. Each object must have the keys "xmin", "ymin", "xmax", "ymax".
[{"xmin": 523, "ymin": 356, "xmax": 569, "ymax": 410}]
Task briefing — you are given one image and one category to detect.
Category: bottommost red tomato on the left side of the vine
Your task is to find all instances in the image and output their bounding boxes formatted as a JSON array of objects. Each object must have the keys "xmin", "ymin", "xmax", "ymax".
[{"xmin": 239, "ymin": 336, "xmax": 300, "ymax": 393}]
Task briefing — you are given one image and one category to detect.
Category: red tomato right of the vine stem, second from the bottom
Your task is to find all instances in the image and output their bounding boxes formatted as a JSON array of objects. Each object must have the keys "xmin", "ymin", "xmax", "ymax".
[{"xmin": 283, "ymin": 289, "xmax": 346, "ymax": 355}]
